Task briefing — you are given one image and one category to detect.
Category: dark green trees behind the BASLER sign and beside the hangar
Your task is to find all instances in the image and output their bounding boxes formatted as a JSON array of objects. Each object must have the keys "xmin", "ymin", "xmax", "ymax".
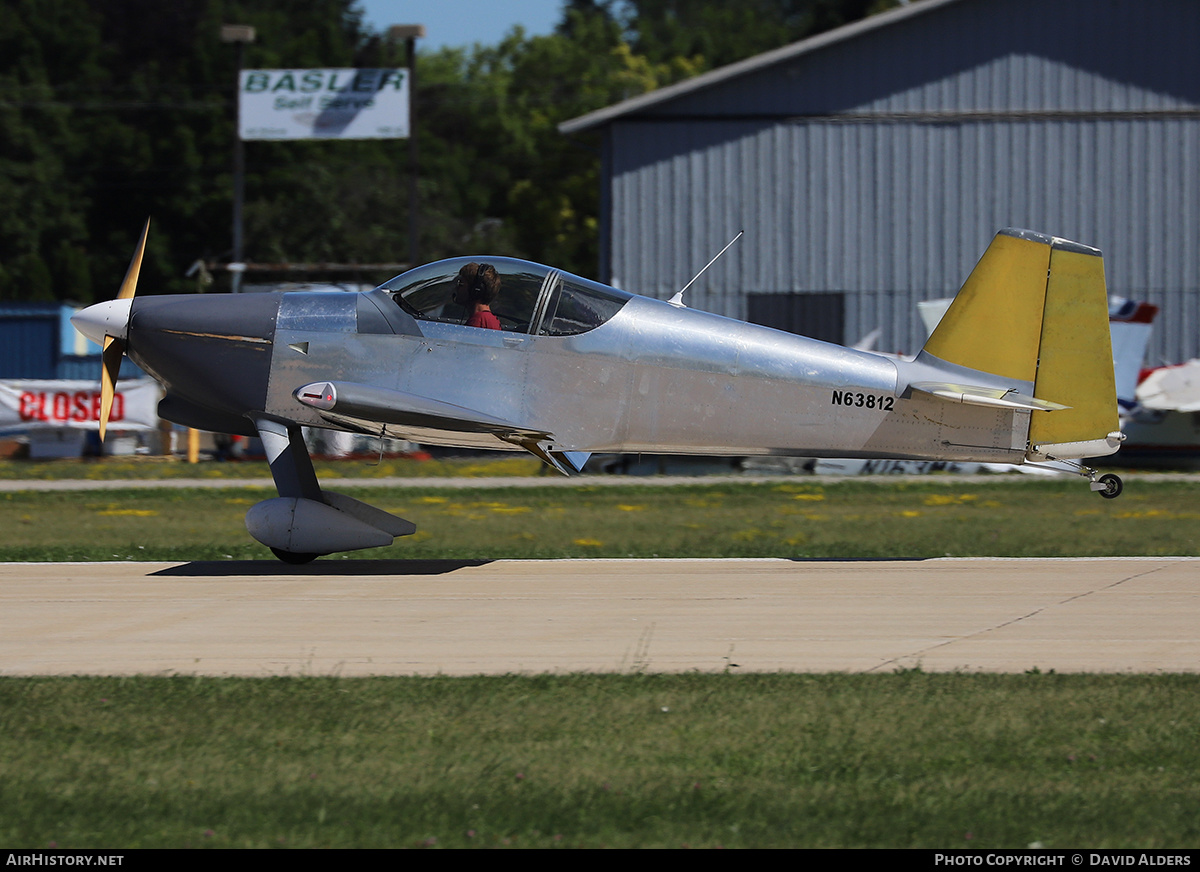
[{"xmin": 0, "ymin": 0, "xmax": 894, "ymax": 302}]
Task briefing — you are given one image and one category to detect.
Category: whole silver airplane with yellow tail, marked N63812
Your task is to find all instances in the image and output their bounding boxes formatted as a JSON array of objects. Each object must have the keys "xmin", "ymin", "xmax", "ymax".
[{"xmin": 72, "ymin": 222, "xmax": 1122, "ymax": 563}]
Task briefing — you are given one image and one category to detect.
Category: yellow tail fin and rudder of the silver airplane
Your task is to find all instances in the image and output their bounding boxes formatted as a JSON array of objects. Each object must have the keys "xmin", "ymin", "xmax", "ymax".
[{"xmin": 922, "ymin": 229, "xmax": 1121, "ymax": 461}]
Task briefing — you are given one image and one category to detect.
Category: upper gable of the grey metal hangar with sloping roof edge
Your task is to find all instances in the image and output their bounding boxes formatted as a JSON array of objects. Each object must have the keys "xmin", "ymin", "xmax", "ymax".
[{"xmin": 559, "ymin": 0, "xmax": 1200, "ymax": 133}]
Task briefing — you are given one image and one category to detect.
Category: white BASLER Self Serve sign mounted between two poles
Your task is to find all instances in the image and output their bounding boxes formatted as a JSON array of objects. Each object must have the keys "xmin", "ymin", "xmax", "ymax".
[{"xmin": 238, "ymin": 68, "xmax": 408, "ymax": 139}]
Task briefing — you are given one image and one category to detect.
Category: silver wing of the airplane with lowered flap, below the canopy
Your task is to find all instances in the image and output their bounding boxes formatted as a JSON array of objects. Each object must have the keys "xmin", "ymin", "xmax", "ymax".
[{"xmin": 293, "ymin": 381, "xmax": 590, "ymax": 475}]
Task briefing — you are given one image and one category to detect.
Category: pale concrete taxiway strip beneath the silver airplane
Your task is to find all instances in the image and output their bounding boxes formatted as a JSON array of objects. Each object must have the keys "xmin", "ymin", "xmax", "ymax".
[{"xmin": 0, "ymin": 558, "xmax": 1200, "ymax": 675}]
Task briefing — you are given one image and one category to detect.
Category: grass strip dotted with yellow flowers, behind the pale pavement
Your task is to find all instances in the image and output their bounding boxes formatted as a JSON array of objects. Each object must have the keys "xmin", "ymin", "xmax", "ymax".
[{"xmin": 0, "ymin": 477, "xmax": 1200, "ymax": 560}]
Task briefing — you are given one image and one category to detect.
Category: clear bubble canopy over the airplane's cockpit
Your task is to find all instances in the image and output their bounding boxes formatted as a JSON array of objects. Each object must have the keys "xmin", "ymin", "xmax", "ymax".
[{"xmin": 379, "ymin": 257, "xmax": 631, "ymax": 336}]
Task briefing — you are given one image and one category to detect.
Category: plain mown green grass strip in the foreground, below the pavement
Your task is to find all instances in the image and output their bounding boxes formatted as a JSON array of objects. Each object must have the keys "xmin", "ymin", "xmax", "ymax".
[{"xmin": 0, "ymin": 670, "xmax": 1200, "ymax": 848}]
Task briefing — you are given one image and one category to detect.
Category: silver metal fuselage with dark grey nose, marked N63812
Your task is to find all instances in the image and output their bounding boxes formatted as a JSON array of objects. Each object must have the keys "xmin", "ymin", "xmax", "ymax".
[{"xmin": 128, "ymin": 283, "xmax": 1028, "ymax": 462}]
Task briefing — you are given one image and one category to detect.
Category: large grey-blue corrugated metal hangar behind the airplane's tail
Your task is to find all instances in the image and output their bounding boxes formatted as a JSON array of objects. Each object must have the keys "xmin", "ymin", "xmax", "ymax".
[{"xmin": 563, "ymin": 0, "xmax": 1200, "ymax": 361}]
